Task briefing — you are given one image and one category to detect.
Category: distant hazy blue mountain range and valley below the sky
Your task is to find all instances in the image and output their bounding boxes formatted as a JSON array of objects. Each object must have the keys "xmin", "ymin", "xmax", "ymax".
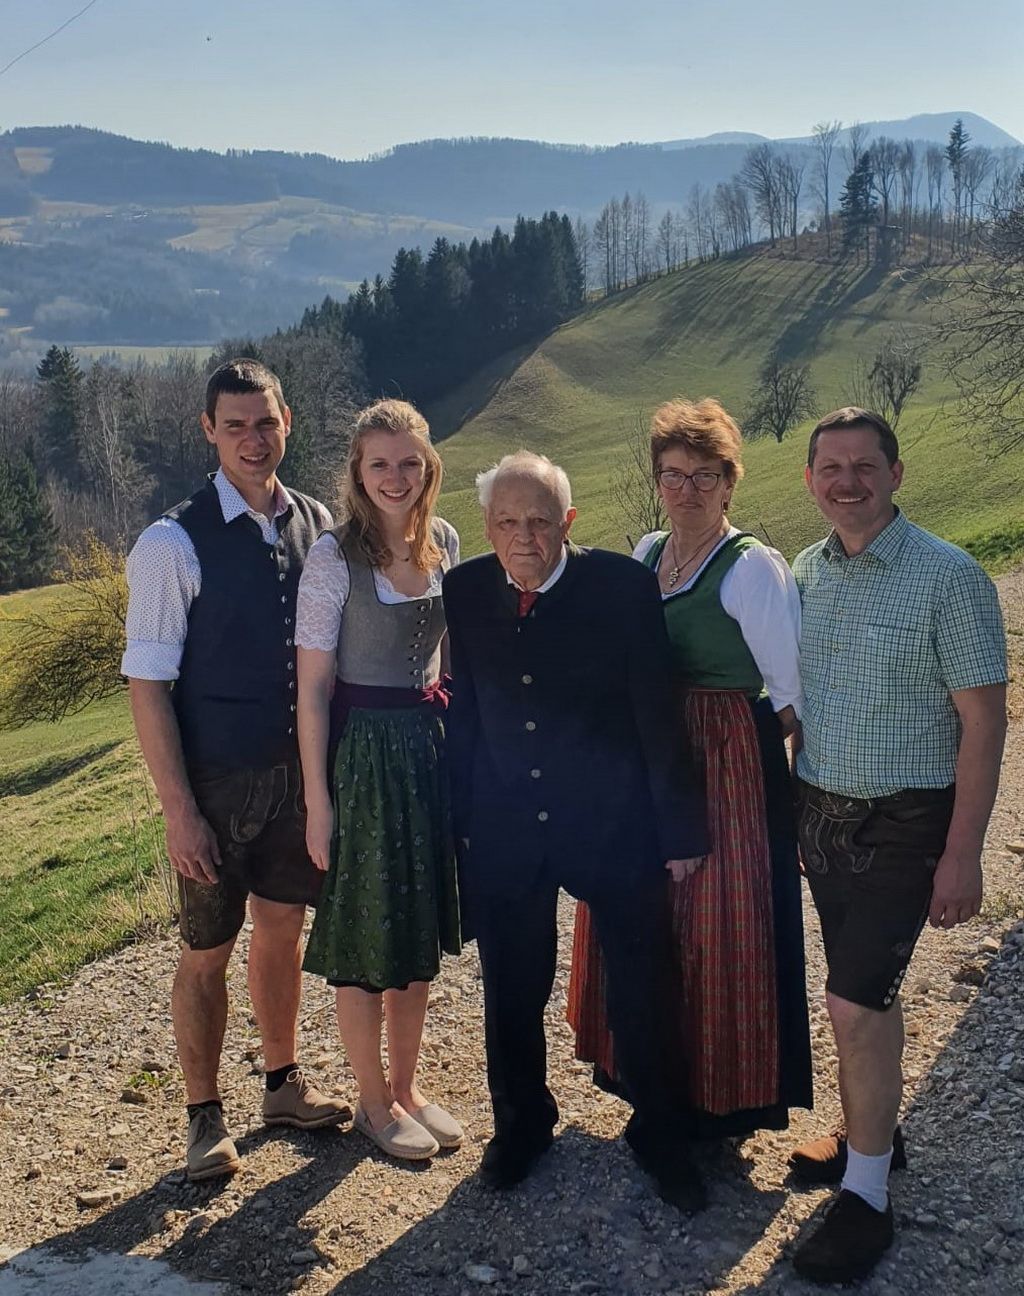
[{"xmin": 0, "ymin": 113, "xmax": 1019, "ymax": 362}]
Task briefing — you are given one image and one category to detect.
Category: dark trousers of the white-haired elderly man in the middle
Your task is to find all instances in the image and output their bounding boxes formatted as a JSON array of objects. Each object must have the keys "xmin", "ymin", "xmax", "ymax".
[{"xmin": 474, "ymin": 868, "xmax": 677, "ymax": 1163}]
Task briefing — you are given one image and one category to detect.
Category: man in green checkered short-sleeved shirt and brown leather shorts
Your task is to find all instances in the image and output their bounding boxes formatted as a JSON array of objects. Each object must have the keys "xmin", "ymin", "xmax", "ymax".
[{"xmin": 791, "ymin": 407, "xmax": 1006, "ymax": 1282}]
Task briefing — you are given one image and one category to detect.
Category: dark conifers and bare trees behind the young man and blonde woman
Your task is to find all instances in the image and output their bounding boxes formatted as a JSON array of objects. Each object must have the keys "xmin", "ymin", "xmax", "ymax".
[{"xmin": 0, "ymin": 211, "xmax": 583, "ymax": 590}]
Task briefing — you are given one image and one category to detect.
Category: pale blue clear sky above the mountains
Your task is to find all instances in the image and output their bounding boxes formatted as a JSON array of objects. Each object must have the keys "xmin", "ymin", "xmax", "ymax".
[{"xmin": 0, "ymin": 0, "xmax": 1024, "ymax": 158}]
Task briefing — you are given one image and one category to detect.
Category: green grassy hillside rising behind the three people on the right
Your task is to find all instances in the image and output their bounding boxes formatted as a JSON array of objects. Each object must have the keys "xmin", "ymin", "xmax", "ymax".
[{"xmin": 430, "ymin": 257, "xmax": 1024, "ymax": 568}]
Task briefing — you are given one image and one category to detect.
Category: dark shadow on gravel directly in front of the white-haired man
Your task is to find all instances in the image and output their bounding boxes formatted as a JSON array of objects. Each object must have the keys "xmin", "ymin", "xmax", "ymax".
[{"xmin": 331, "ymin": 1126, "xmax": 785, "ymax": 1296}]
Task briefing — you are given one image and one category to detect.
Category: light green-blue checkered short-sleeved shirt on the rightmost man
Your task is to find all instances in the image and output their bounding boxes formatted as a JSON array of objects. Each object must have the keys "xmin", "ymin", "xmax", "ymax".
[{"xmin": 793, "ymin": 511, "xmax": 1007, "ymax": 797}]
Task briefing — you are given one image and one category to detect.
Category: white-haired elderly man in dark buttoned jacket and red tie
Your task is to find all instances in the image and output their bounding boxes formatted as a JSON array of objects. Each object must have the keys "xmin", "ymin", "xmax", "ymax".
[{"xmin": 445, "ymin": 452, "xmax": 706, "ymax": 1210}]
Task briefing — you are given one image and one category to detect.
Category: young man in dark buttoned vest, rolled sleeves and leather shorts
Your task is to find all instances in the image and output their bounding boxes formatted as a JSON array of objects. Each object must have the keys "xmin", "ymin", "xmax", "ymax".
[{"xmin": 121, "ymin": 359, "xmax": 351, "ymax": 1179}]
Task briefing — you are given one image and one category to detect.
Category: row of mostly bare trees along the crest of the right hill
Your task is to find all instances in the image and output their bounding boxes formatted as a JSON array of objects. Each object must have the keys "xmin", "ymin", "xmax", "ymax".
[{"xmin": 576, "ymin": 118, "xmax": 1020, "ymax": 295}]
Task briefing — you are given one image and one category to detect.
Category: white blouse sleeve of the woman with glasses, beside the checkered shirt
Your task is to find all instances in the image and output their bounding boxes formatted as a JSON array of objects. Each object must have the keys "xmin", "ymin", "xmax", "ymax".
[{"xmin": 721, "ymin": 544, "xmax": 801, "ymax": 715}]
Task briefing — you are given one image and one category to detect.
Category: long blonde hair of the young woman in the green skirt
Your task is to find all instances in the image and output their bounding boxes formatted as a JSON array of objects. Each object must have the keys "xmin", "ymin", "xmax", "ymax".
[{"xmin": 336, "ymin": 400, "xmax": 443, "ymax": 572}]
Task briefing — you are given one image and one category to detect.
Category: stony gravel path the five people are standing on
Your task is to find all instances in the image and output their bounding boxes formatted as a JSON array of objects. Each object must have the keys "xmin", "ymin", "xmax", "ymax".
[{"xmin": 0, "ymin": 574, "xmax": 1024, "ymax": 1296}]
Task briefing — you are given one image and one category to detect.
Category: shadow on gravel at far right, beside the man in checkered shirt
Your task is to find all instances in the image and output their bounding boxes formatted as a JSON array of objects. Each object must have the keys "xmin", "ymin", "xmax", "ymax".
[{"xmin": 731, "ymin": 921, "xmax": 1024, "ymax": 1296}]
